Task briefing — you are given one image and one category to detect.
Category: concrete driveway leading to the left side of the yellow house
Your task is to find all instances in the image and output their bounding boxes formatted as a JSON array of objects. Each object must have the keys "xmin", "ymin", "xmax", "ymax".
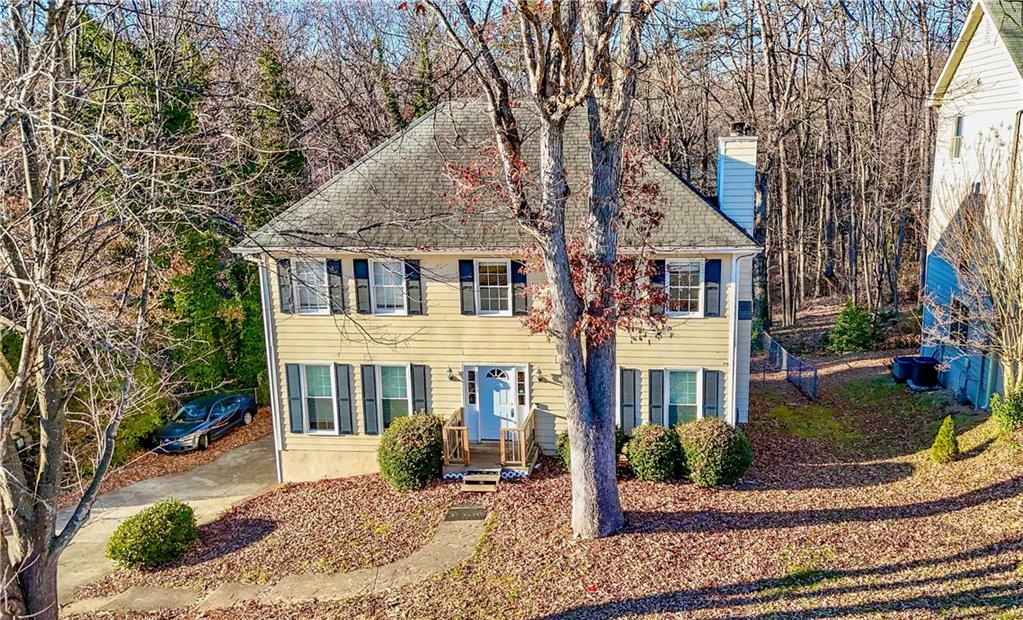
[{"xmin": 57, "ymin": 436, "xmax": 276, "ymax": 600}]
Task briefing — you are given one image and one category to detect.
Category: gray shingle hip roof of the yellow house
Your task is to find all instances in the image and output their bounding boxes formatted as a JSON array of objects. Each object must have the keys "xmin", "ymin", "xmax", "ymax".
[{"xmin": 235, "ymin": 99, "xmax": 755, "ymax": 253}]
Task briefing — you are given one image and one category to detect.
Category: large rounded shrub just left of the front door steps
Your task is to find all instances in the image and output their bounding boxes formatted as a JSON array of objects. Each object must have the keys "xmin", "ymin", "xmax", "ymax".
[{"xmin": 376, "ymin": 411, "xmax": 444, "ymax": 491}]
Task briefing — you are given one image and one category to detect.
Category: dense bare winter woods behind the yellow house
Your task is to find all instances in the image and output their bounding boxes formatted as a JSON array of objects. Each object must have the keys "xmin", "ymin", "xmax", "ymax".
[{"xmin": 186, "ymin": 0, "xmax": 970, "ymax": 333}]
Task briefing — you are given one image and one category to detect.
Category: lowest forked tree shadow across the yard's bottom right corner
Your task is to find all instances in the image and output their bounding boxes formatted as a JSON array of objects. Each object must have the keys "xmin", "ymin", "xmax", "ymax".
[{"xmin": 545, "ymin": 537, "xmax": 1023, "ymax": 619}]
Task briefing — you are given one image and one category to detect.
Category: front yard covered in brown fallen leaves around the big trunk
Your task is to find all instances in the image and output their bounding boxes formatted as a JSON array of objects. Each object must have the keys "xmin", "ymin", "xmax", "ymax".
[{"xmin": 72, "ymin": 359, "xmax": 1023, "ymax": 619}]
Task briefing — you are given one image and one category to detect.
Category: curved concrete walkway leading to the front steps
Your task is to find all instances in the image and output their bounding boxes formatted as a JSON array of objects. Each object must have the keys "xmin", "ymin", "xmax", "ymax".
[{"xmin": 61, "ymin": 505, "xmax": 486, "ymax": 616}]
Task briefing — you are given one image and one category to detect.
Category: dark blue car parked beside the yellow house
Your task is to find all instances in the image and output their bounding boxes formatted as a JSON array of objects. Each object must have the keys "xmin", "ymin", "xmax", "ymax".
[{"xmin": 157, "ymin": 394, "xmax": 256, "ymax": 452}]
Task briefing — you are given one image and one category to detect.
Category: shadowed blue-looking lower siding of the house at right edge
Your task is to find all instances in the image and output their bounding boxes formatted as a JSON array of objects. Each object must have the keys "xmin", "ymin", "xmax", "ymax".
[{"xmin": 921, "ymin": 252, "xmax": 1002, "ymax": 408}]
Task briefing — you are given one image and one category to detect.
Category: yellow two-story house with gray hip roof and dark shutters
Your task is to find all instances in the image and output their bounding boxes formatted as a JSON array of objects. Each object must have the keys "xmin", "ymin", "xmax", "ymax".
[{"xmin": 234, "ymin": 101, "xmax": 759, "ymax": 481}]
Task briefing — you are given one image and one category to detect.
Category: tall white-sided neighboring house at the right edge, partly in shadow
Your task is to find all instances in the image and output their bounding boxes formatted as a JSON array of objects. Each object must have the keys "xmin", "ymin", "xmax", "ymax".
[{"xmin": 923, "ymin": 0, "xmax": 1023, "ymax": 408}]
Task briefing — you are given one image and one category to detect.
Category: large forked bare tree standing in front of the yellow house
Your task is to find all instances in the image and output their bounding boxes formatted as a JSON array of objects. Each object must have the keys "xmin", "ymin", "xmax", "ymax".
[{"xmin": 429, "ymin": 0, "xmax": 656, "ymax": 538}]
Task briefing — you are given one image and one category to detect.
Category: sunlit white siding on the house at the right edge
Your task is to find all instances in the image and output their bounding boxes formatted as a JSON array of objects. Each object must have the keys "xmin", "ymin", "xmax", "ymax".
[{"xmin": 928, "ymin": 4, "xmax": 1023, "ymax": 252}]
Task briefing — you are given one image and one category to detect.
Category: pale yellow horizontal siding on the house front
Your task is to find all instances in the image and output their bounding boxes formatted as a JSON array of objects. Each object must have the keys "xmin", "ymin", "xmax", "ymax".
[{"xmin": 270, "ymin": 255, "xmax": 735, "ymax": 480}]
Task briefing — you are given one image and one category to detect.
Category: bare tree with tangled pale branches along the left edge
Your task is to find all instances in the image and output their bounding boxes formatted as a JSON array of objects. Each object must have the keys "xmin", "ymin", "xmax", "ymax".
[{"xmin": 0, "ymin": 0, "xmax": 234, "ymax": 618}]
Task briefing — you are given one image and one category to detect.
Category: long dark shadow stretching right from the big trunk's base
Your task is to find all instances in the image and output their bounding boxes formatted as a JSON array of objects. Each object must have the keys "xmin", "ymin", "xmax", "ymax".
[{"xmin": 622, "ymin": 476, "xmax": 1023, "ymax": 536}]
